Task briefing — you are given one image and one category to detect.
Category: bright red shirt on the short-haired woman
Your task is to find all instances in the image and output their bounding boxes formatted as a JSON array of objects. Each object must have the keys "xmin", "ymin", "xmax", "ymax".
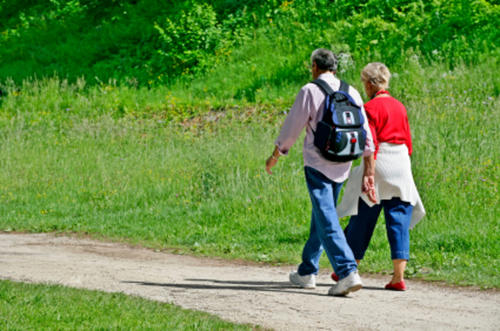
[{"xmin": 365, "ymin": 91, "xmax": 412, "ymax": 159}]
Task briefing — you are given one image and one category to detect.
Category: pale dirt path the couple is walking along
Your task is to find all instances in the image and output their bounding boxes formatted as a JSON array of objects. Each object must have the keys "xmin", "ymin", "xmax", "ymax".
[{"xmin": 0, "ymin": 233, "xmax": 500, "ymax": 330}]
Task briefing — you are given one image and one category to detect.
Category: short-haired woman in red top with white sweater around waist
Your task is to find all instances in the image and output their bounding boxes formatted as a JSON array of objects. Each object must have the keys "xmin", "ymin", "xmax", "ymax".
[{"xmin": 332, "ymin": 62, "xmax": 425, "ymax": 291}]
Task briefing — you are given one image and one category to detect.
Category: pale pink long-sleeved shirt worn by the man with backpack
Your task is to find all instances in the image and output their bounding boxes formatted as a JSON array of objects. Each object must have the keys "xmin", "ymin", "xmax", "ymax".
[{"xmin": 275, "ymin": 72, "xmax": 375, "ymax": 183}]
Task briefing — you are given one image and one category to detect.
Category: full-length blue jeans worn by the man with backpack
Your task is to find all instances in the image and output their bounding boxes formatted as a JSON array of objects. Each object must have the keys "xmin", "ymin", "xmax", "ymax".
[{"xmin": 298, "ymin": 167, "xmax": 357, "ymax": 278}]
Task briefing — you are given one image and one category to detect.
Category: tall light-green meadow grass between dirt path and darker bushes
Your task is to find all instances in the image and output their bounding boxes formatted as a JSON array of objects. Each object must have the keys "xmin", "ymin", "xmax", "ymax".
[{"xmin": 0, "ymin": 58, "xmax": 500, "ymax": 288}]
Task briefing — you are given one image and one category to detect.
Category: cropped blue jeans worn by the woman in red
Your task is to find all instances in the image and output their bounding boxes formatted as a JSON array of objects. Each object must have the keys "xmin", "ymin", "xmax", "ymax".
[{"xmin": 345, "ymin": 198, "xmax": 413, "ymax": 260}]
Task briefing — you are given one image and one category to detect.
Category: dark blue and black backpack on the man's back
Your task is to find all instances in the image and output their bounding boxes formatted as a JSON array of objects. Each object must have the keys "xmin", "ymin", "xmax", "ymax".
[{"xmin": 312, "ymin": 79, "xmax": 366, "ymax": 162}]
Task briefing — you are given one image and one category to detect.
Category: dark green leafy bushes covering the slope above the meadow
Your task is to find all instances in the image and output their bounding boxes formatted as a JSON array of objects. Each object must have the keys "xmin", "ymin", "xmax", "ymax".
[{"xmin": 0, "ymin": 0, "xmax": 500, "ymax": 85}]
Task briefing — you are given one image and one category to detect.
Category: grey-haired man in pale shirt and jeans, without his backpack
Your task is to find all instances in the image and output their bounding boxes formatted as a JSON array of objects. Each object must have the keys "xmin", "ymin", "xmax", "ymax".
[{"xmin": 266, "ymin": 48, "xmax": 376, "ymax": 296}]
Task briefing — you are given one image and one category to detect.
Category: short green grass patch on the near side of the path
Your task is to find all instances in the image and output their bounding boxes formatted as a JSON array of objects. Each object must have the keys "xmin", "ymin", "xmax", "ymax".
[{"xmin": 0, "ymin": 281, "xmax": 255, "ymax": 330}]
